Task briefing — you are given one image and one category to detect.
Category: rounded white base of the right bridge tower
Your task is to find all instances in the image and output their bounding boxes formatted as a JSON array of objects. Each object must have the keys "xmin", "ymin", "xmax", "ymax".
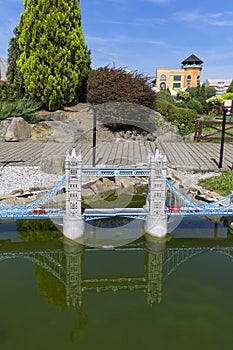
[{"xmin": 144, "ymin": 214, "xmax": 167, "ymax": 238}]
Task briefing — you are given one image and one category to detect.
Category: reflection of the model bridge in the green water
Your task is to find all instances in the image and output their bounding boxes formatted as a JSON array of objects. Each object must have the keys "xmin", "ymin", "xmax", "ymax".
[{"xmin": 0, "ymin": 236, "xmax": 233, "ymax": 310}]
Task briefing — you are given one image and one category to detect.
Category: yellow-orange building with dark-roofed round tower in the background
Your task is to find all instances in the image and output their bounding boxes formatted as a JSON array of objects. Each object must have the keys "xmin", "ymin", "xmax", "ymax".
[{"xmin": 155, "ymin": 55, "xmax": 203, "ymax": 90}]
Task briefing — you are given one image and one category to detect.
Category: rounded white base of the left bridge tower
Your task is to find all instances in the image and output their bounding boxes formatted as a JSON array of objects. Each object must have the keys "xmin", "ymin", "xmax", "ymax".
[{"xmin": 63, "ymin": 215, "xmax": 84, "ymax": 241}]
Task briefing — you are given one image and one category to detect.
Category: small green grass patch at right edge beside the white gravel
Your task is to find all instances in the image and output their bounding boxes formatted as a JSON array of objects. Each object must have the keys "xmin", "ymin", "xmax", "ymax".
[{"xmin": 199, "ymin": 170, "xmax": 233, "ymax": 196}]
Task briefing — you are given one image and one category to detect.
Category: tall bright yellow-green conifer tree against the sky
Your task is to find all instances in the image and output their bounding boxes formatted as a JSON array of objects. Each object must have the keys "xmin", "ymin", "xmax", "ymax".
[{"xmin": 18, "ymin": 0, "xmax": 90, "ymax": 110}]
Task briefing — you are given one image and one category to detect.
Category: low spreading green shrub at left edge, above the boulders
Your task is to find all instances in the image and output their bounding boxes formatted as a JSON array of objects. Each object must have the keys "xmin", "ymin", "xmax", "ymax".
[{"xmin": 0, "ymin": 98, "xmax": 41, "ymax": 123}]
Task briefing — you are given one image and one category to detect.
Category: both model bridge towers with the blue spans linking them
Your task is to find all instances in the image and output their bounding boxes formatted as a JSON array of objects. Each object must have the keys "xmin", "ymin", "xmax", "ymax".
[{"xmin": 63, "ymin": 148, "xmax": 167, "ymax": 240}]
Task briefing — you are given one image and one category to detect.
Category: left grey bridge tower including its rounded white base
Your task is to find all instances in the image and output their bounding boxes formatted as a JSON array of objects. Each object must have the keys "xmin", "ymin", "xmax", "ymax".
[{"xmin": 63, "ymin": 148, "xmax": 84, "ymax": 240}]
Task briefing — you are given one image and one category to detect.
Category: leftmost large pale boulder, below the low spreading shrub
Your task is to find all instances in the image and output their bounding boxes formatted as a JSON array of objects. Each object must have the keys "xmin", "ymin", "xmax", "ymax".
[{"xmin": 5, "ymin": 117, "xmax": 32, "ymax": 141}]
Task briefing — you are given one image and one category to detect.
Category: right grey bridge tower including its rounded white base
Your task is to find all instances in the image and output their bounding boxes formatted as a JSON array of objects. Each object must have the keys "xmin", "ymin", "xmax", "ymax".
[{"xmin": 145, "ymin": 149, "xmax": 167, "ymax": 237}]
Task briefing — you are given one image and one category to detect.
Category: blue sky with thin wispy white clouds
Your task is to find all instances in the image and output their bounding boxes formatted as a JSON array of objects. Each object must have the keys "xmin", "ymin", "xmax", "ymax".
[{"xmin": 0, "ymin": 0, "xmax": 233, "ymax": 81}]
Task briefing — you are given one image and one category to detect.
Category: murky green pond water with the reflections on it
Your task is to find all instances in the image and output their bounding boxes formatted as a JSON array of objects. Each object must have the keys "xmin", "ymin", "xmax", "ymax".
[{"xmin": 0, "ymin": 218, "xmax": 233, "ymax": 350}]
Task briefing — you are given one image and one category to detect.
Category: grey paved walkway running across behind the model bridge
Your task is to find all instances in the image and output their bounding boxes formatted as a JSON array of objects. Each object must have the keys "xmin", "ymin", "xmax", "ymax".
[{"xmin": 0, "ymin": 141, "xmax": 233, "ymax": 172}]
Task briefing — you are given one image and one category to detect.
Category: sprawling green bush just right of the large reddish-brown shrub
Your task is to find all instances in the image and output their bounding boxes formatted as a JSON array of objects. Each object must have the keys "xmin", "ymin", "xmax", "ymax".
[{"xmin": 155, "ymin": 99, "xmax": 197, "ymax": 135}]
